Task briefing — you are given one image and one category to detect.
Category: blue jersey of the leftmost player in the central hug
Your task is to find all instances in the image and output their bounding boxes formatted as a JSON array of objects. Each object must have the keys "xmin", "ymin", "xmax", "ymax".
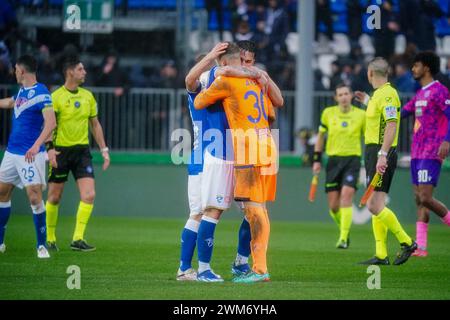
[{"xmin": 188, "ymin": 85, "xmax": 207, "ymax": 176}]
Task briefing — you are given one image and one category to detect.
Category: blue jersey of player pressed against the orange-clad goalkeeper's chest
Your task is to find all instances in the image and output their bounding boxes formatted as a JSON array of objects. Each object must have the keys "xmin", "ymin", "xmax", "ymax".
[{"xmin": 205, "ymin": 66, "xmax": 234, "ymax": 161}]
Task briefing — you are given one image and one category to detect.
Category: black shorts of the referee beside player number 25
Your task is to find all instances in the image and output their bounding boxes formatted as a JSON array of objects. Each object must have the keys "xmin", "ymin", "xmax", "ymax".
[{"xmin": 48, "ymin": 146, "xmax": 94, "ymax": 183}]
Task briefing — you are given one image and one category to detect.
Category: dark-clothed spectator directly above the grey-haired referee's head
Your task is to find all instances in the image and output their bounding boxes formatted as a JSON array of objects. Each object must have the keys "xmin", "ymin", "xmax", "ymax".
[{"xmin": 373, "ymin": 0, "xmax": 402, "ymax": 60}]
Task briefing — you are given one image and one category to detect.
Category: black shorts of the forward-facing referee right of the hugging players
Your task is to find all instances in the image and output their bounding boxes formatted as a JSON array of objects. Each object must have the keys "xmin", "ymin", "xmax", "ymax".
[{"xmin": 325, "ymin": 156, "xmax": 361, "ymax": 193}]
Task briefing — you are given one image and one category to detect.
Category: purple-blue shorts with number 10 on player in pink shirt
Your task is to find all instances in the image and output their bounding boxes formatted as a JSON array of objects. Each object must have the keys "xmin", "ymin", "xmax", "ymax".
[{"xmin": 411, "ymin": 159, "xmax": 442, "ymax": 187}]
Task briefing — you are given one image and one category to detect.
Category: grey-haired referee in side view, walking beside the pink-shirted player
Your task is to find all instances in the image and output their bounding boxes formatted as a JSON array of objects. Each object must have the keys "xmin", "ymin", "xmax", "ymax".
[{"xmin": 355, "ymin": 58, "xmax": 417, "ymax": 265}]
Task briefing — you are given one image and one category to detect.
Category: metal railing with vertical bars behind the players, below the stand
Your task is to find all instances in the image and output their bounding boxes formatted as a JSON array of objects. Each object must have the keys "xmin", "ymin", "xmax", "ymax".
[{"xmin": 0, "ymin": 86, "xmax": 413, "ymax": 152}]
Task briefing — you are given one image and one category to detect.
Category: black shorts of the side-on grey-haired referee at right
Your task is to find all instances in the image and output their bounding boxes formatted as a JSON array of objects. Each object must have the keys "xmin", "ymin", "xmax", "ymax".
[{"xmin": 365, "ymin": 144, "xmax": 398, "ymax": 193}]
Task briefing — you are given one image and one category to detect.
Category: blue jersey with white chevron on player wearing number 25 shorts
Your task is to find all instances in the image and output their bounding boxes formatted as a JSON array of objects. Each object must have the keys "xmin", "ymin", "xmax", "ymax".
[{"xmin": 6, "ymin": 83, "xmax": 52, "ymax": 155}]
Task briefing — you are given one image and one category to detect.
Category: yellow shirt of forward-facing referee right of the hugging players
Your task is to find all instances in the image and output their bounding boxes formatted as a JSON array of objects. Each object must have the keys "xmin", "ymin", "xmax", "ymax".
[{"xmin": 319, "ymin": 106, "xmax": 366, "ymax": 157}]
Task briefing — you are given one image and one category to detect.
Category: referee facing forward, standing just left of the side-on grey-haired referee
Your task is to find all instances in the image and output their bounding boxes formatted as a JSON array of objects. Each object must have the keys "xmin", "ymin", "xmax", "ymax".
[{"xmin": 313, "ymin": 84, "xmax": 366, "ymax": 249}]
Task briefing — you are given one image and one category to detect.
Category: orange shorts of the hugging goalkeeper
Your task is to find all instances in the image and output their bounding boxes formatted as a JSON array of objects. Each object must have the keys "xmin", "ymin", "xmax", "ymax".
[{"xmin": 234, "ymin": 167, "xmax": 277, "ymax": 203}]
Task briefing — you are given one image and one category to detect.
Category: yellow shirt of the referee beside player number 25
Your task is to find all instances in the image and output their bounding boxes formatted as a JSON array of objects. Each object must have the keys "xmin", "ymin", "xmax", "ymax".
[{"xmin": 52, "ymin": 86, "xmax": 97, "ymax": 147}]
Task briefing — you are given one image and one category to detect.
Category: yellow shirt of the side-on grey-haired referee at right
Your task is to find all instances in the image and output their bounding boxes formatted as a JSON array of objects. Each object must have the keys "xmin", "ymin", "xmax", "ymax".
[{"xmin": 365, "ymin": 82, "xmax": 401, "ymax": 147}]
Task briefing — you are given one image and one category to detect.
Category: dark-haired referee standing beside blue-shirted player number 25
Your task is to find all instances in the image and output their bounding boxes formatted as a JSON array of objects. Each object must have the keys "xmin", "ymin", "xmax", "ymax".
[{"xmin": 46, "ymin": 57, "xmax": 110, "ymax": 251}]
